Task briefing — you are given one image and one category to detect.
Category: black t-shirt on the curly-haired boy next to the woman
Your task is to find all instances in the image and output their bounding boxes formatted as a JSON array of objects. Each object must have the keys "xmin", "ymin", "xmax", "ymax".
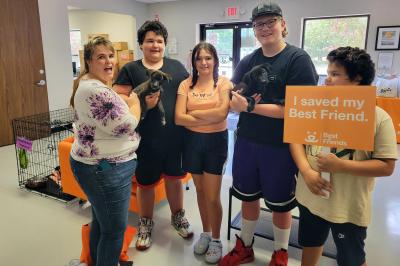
[{"xmin": 114, "ymin": 58, "xmax": 189, "ymax": 149}]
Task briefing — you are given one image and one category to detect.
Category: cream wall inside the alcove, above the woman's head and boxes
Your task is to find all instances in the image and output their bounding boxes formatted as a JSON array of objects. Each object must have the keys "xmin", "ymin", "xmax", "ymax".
[{"xmin": 68, "ymin": 9, "xmax": 137, "ymax": 50}]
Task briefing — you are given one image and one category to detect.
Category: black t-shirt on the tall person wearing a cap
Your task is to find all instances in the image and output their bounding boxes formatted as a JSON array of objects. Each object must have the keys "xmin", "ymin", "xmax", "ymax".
[{"xmin": 232, "ymin": 44, "xmax": 318, "ymax": 145}]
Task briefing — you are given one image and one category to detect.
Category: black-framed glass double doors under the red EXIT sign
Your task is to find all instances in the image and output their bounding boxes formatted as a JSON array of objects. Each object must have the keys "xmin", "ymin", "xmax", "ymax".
[{"xmin": 200, "ymin": 22, "xmax": 260, "ymax": 79}]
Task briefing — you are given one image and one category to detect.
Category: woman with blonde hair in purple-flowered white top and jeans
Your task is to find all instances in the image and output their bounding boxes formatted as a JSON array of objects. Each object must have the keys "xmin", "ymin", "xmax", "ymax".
[{"xmin": 70, "ymin": 37, "xmax": 140, "ymax": 266}]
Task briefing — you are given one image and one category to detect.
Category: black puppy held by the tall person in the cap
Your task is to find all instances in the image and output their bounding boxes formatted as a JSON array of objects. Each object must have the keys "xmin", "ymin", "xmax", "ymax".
[{"xmin": 233, "ymin": 64, "xmax": 271, "ymax": 105}]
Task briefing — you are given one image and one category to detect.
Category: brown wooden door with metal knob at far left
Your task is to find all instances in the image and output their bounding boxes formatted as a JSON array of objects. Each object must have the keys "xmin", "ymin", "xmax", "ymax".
[{"xmin": 0, "ymin": 0, "xmax": 49, "ymax": 146}]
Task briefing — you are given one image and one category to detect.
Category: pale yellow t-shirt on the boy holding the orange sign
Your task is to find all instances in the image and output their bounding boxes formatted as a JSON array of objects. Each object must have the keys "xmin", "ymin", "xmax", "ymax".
[{"xmin": 296, "ymin": 107, "xmax": 397, "ymax": 226}]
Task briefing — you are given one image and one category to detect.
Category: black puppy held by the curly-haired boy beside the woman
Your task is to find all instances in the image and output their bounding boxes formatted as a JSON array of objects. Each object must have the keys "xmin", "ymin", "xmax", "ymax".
[{"xmin": 133, "ymin": 70, "xmax": 171, "ymax": 125}]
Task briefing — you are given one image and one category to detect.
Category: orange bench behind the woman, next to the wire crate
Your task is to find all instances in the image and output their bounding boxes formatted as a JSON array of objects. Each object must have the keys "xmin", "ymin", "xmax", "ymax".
[{"xmin": 58, "ymin": 137, "xmax": 192, "ymax": 213}]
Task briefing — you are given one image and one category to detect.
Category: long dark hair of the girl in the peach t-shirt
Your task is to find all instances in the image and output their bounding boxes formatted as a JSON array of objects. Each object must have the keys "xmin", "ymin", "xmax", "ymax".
[{"xmin": 190, "ymin": 42, "xmax": 219, "ymax": 89}]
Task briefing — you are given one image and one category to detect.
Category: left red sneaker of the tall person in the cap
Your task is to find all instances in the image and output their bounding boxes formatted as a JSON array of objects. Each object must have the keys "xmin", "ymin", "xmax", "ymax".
[{"xmin": 218, "ymin": 235, "xmax": 254, "ymax": 266}]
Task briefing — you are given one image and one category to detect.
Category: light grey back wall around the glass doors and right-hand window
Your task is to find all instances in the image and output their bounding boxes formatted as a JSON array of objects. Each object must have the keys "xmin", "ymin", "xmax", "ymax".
[{"xmin": 149, "ymin": 0, "xmax": 400, "ymax": 73}]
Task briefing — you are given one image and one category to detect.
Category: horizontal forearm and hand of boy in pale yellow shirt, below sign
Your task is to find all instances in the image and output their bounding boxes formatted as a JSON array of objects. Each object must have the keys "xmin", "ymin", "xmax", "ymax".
[{"xmin": 317, "ymin": 153, "xmax": 395, "ymax": 177}]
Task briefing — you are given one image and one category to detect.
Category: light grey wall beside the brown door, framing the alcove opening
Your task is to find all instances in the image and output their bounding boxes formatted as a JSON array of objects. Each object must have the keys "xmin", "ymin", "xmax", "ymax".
[{"xmin": 38, "ymin": 0, "xmax": 148, "ymax": 110}]
